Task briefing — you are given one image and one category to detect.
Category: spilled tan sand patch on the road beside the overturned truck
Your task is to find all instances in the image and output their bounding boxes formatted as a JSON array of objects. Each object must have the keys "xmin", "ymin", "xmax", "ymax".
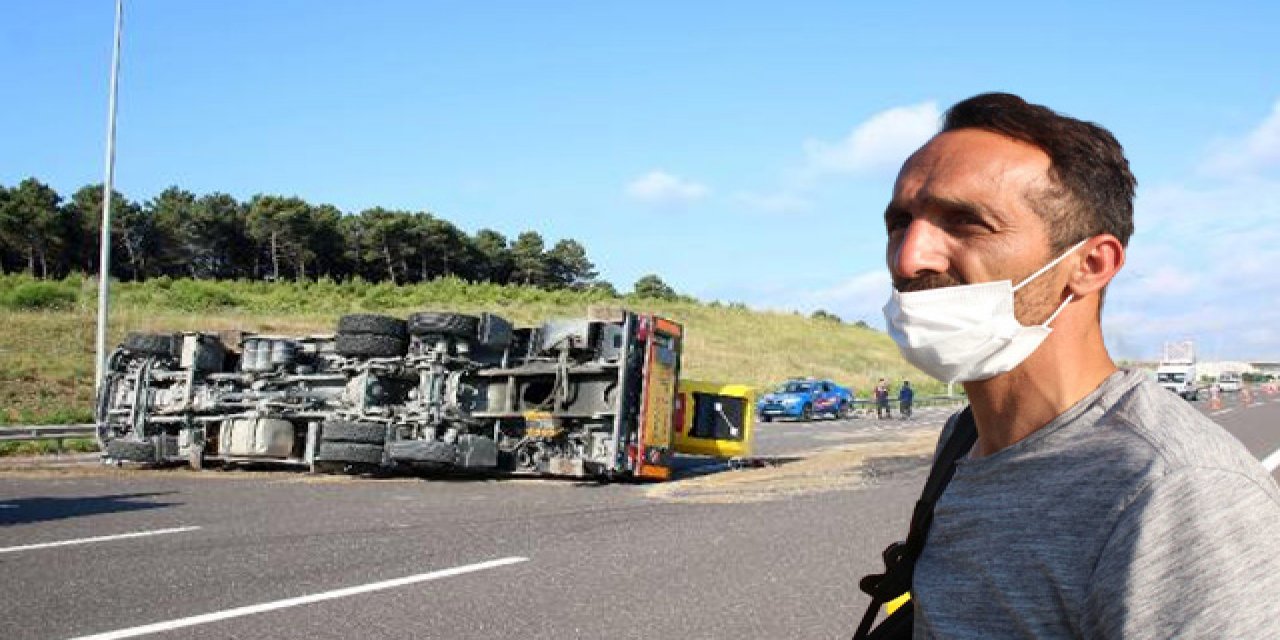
[{"xmin": 646, "ymin": 426, "xmax": 938, "ymax": 504}]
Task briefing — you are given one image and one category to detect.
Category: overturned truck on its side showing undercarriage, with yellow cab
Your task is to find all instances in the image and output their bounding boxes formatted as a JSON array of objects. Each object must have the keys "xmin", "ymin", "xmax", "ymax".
[{"xmin": 96, "ymin": 308, "xmax": 751, "ymax": 479}]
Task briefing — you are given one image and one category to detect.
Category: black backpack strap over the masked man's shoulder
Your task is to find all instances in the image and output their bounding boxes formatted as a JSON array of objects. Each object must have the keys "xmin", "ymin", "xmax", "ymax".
[{"xmin": 854, "ymin": 407, "xmax": 978, "ymax": 640}]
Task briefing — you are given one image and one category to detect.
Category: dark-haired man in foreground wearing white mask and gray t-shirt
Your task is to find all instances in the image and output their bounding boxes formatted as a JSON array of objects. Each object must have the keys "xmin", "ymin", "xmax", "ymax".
[{"xmin": 884, "ymin": 93, "xmax": 1280, "ymax": 639}]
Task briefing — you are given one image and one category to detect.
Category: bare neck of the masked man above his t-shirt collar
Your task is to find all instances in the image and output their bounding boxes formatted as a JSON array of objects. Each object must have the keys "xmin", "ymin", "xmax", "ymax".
[{"xmin": 964, "ymin": 334, "xmax": 1116, "ymax": 456}]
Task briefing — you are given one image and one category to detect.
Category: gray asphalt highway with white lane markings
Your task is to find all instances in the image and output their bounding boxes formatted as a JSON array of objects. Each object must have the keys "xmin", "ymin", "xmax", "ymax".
[{"xmin": 0, "ymin": 397, "xmax": 1280, "ymax": 639}]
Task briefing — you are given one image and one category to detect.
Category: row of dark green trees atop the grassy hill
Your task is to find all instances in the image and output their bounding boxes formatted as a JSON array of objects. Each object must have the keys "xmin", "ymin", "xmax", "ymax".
[{"xmin": 0, "ymin": 178, "xmax": 640, "ymax": 294}]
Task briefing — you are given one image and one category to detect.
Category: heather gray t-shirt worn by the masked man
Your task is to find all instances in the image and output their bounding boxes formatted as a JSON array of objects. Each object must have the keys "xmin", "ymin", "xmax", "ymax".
[{"xmin": 913, "ymin": 371, "xmax": 1280, "ymax": 639}]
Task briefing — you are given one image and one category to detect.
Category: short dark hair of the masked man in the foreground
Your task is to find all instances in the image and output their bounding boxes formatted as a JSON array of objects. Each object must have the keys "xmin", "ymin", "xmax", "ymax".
[{"xmin": 942, "ymin": 93, "xmax": 1138, "ymax": 251}]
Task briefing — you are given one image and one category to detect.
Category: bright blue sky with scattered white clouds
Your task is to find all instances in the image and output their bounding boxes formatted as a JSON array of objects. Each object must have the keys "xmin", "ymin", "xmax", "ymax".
[{"xmin": 0, "ymin": 0, "xmax": 1280, "ymax": 358}]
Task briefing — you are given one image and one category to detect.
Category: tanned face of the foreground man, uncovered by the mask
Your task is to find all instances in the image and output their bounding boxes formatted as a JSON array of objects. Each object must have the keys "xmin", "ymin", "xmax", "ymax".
[{"xmin": 884, "ymin": 129, "xmax": 1061, "ymax": 325}]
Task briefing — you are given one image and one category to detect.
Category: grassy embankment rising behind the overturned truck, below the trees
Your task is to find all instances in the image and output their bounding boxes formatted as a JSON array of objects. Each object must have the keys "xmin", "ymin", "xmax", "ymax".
[{"xmin": 0, "ymin": 275, "xmax": 940, "ymax": 445}]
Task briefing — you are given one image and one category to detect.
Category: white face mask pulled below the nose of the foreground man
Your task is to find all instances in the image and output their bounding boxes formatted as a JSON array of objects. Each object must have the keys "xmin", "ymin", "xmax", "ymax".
[{"xmin": 884, "ymin": 241, "xmax": 1085, "ymax": 383}]
